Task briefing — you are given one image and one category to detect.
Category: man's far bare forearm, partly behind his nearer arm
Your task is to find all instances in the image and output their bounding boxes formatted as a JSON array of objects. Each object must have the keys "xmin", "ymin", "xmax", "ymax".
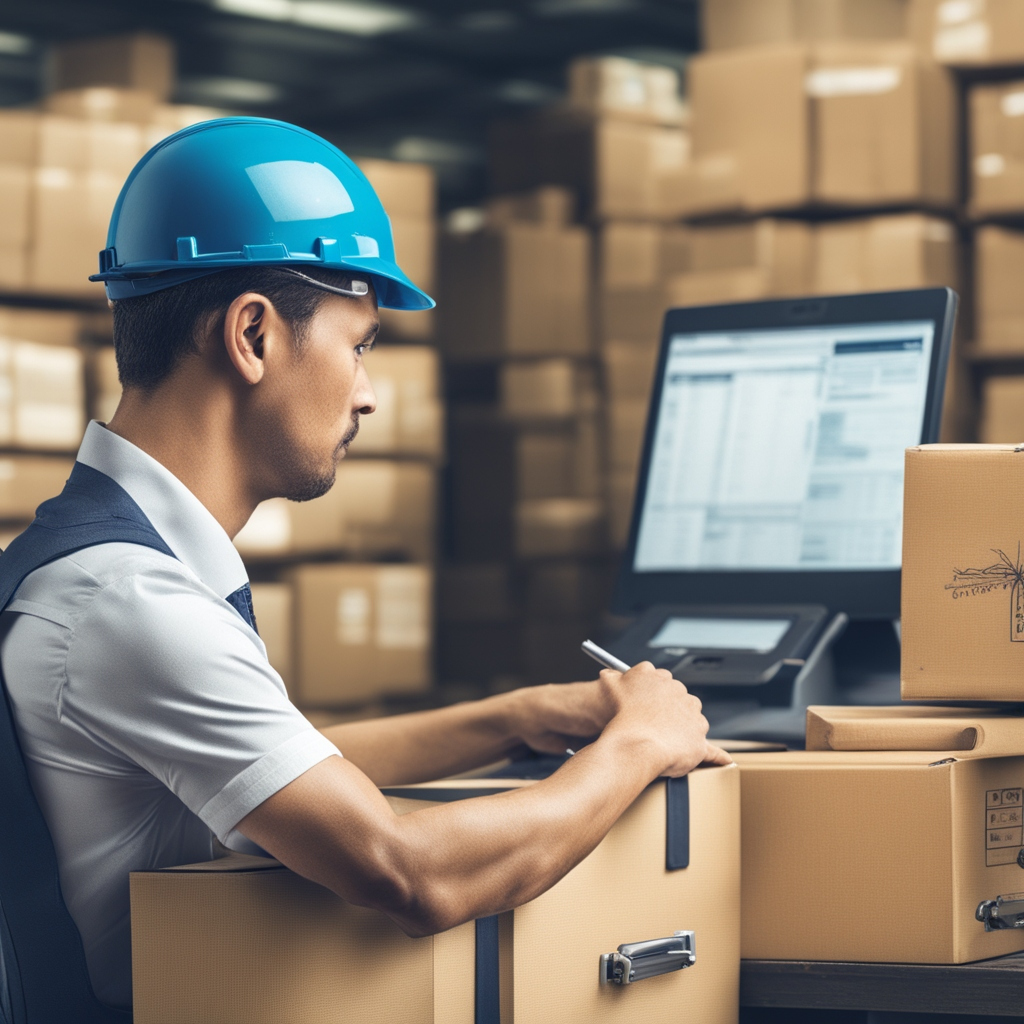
[{"xmin": 323, "ymin": 693, "xmax": 519, "ymax": 785}]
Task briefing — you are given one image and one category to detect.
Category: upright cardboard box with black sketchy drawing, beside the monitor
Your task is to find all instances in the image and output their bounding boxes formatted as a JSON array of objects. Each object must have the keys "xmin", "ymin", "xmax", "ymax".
[{"xmin": 900, "ymin": 444, "xmax": 1024, "ymax": 701}]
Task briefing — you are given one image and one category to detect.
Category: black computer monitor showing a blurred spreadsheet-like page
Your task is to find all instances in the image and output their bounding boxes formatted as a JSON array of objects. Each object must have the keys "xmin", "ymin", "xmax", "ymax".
[{"xmin": 612, "ymin": 289, "xmax": 957, "ymax": 618}]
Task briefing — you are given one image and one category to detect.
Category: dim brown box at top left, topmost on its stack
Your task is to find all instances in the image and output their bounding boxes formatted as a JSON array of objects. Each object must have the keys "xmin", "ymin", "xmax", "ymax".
[{"xmin": 47, "ymin": 32, "xmax": 174, "ymax": 99}]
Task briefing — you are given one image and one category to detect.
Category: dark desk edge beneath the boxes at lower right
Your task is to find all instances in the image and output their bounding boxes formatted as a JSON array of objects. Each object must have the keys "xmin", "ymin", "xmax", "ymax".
[{"xmin": 739, "ymin": 953, "xmax": 1024, "ymax": 1017}]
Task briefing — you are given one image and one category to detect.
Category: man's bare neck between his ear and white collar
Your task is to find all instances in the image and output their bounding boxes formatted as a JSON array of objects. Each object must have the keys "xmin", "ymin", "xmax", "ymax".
[{"xmin": 108, "ymin": 381, "xmax": 256, "ymax": 538}]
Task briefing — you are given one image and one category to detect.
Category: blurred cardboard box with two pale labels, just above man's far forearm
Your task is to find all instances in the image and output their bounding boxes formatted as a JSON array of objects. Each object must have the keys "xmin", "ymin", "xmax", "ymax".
[{"xmin": 288, "ymin": 564, "xmax": 433, "ymax": 708}]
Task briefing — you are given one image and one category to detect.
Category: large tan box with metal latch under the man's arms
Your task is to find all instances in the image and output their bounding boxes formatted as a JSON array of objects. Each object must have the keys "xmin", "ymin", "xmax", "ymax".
[{"xmin": 131, "ymin": 766, "xmax": 740, "ymax": 1024}]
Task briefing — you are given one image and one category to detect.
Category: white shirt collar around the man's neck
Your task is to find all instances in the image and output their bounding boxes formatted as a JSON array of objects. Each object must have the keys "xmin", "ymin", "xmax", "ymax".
[{"xmin": 78, "ymin": 420, "xmax": 249, "ymax": 597}]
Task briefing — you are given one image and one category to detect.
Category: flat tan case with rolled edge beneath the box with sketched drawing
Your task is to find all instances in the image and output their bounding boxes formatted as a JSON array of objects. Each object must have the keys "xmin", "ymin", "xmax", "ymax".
[{"xmin": 807, "ymin": 707, "xmax": 1024, "ymax": 759}]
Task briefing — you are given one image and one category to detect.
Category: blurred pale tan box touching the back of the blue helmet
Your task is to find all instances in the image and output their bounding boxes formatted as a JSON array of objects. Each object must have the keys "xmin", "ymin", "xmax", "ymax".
[{"xmin": 29, "ymin": 167, "xmax": 124, "ymax": 299}]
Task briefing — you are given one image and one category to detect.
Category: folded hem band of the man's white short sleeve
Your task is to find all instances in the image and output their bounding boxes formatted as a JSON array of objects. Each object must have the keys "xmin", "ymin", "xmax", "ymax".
[{"xmin": 199, "ymin": 728, "xmax": 342, "ymax": 844}]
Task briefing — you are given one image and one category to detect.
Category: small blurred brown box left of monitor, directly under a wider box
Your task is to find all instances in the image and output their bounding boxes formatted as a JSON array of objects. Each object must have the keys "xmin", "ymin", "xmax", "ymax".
[{"xmin": 498, "ymin": 358, "xmax": 599, "ymax": 421}]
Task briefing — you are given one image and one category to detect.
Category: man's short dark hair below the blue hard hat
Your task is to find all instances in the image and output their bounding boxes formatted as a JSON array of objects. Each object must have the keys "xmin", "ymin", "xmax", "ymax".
[{"xmin": 114, "ymin": 266, "xmax": 351, "ymax": 388}]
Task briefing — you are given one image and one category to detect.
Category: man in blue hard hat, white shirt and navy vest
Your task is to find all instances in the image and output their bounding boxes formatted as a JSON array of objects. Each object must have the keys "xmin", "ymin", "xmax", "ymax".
[{"xmin": 0, "ymin": 118, "xmax": 728, "ymax": 1007}]
